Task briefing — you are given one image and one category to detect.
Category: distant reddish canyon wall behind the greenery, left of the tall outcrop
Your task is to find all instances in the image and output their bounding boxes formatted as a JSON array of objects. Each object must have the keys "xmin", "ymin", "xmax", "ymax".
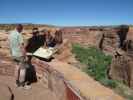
[{"xmin": 63, "ymin": 30, "xmax": 102, "ymax": 47}]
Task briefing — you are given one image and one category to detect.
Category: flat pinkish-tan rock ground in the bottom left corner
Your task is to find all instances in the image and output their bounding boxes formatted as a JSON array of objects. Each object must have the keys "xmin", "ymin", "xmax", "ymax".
[{"xmin": 0, "ymin": 76, "xmax": 58, "ymax": 100}]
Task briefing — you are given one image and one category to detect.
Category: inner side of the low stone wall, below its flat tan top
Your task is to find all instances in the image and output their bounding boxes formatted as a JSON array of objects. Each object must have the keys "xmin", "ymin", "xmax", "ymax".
[{"xmin": 33, "ymin": 59, "xmax": 83, "ymax": 100}]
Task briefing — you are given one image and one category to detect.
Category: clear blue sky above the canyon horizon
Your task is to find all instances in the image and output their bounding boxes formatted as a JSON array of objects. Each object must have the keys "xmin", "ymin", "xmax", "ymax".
[{"xmin": 0, "ymin": 0, "xmax": 133, "ymax": 26}]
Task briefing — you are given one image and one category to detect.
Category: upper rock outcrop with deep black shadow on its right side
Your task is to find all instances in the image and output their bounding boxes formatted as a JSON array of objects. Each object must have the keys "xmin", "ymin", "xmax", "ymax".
[{"xmin": 99, "ymin": 25, "xmax": 129, "ymax": 55}]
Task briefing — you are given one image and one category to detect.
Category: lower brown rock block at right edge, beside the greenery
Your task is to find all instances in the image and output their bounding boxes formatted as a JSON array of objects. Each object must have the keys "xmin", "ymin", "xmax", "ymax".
[{"xmin": 109, "ymin": 51, "xmax": 130, "ymax": 86}]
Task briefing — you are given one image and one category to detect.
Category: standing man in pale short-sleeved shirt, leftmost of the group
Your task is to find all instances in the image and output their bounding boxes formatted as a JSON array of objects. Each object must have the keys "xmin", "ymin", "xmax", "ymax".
[{"xmin": 9, "ymin": 24, "xmax": 30, "ymax": 87}]
